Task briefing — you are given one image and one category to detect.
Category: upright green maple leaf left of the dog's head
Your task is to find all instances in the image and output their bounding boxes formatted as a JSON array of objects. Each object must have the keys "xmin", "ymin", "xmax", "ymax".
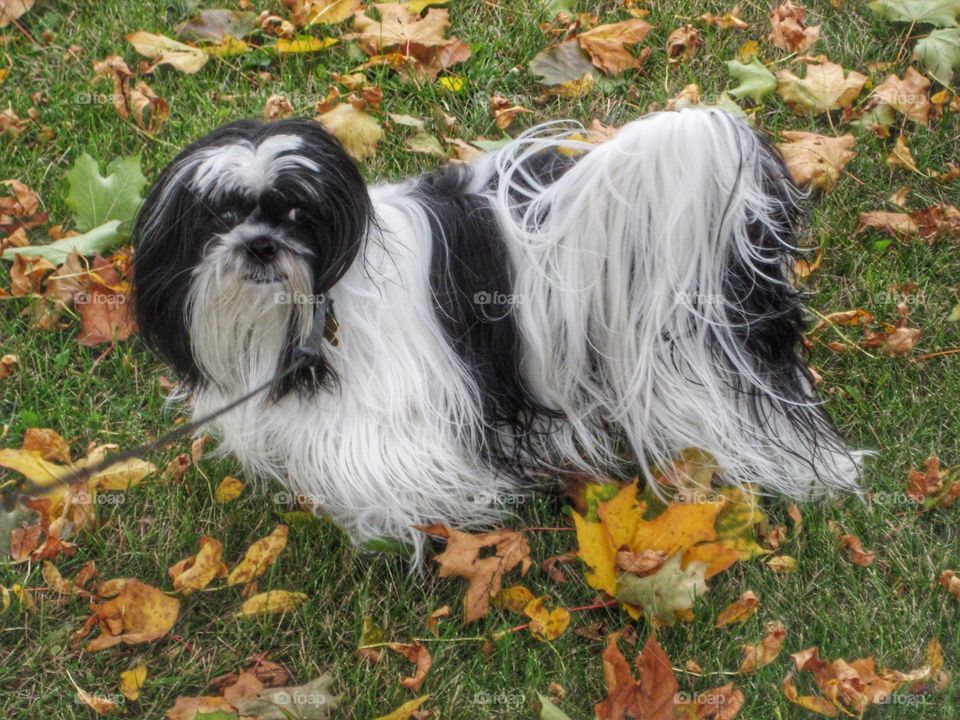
[{"xmin": 66, "ymin": 153, "xmax": 147, "ymax": 237}]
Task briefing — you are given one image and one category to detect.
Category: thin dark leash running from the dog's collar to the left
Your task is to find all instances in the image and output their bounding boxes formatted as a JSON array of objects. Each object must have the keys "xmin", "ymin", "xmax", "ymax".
[{"xmin": 7, "ymin": 294, "xmax": 339, "ymax": 497}]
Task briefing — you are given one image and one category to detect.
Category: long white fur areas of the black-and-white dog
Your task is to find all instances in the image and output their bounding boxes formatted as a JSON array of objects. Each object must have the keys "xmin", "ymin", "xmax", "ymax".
[{"xmin": 190, "ymin": 110, "xmax": 858, "ymax": 553}]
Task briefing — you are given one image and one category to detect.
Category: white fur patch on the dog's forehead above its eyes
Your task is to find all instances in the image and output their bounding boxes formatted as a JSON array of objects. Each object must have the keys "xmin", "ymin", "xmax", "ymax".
[{"xmin": 190, "ymin": 135, "xmax": 320, "ymax": 197}]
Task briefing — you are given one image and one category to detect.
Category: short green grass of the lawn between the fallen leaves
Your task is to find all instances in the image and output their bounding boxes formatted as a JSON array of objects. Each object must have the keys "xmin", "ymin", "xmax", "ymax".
[{"xmin": 0, "ymin": 0, "xmax": 960, "ymax": 720}]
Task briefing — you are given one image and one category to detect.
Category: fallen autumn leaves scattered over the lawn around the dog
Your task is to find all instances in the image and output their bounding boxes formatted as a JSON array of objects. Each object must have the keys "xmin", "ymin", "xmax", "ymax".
[{"xmin": 0, "ymin": 0, "xmax": 960, "ymax": 720}]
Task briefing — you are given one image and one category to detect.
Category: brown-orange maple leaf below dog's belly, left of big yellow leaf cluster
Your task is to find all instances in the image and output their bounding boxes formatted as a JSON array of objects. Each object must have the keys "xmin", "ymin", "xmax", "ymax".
[{"xmin": 415, "ymin": 525, "xmax": 532, "ymax": 622}]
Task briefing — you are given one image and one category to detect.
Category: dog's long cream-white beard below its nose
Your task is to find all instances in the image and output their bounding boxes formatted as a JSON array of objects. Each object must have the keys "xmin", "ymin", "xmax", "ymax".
[{"xmin": 187, "ymin": 243, "xmax": 313, "ymax": 394}]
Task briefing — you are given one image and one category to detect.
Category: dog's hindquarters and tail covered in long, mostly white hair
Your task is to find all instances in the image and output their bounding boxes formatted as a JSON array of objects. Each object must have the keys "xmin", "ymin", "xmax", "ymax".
[{"xmin": 496, "ymin": 110, "xmax": 860, "ymax": 497}]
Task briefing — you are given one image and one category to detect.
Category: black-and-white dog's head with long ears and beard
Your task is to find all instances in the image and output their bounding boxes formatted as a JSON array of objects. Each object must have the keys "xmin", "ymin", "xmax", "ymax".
[{"xmin": 133, "ymin": 120, "xmax": 371, "ymax": 388}]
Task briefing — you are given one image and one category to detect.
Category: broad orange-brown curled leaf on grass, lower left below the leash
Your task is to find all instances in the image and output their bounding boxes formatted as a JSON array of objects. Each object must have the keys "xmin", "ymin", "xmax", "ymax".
[{"xmin": 74, "ymin": 578, "xmax": 180, "ymax": 652}]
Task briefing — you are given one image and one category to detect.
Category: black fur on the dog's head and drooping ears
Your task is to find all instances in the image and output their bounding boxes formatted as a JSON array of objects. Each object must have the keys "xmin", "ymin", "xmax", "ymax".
[{"xmin": 127, "ymin": 120, "xmax": 373, "ymax": 397}]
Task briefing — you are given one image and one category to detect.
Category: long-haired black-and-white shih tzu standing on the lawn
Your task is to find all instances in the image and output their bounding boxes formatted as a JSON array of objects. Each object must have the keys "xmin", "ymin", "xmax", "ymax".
[{"xmin": 134, "ymin": 109, "xmax": 860, "ymax": 551}]
